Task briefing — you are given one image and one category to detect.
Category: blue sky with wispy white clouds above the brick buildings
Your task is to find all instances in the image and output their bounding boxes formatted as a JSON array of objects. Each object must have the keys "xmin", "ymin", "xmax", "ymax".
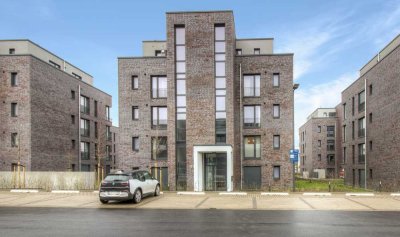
[{"xmin": 0, "ymin": 0, "xmax": 400, "ymax": 146}]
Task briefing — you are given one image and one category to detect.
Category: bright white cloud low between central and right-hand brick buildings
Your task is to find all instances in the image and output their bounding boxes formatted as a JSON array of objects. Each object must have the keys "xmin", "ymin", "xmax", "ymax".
[{"xmin": 294, "ymin": 72, "xmax": 358, "ymax": 146}]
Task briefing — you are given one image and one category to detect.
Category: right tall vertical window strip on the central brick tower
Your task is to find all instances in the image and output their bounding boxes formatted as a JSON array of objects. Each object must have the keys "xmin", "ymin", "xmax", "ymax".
[{"xmin": 214, "ymin": 25, "xmax": 226, "ymax": 143}]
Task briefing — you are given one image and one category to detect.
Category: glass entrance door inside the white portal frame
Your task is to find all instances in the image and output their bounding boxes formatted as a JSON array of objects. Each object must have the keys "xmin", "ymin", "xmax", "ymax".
[{"xmin": 204, "ymin": 153, "xmax": 226, "ymax": 191}]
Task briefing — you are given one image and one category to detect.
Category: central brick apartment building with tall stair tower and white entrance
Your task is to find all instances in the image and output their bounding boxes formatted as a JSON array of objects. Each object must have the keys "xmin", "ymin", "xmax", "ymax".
[{"xmin": 117, "ymin": 11, "xmax": 294, "ymax": 191}]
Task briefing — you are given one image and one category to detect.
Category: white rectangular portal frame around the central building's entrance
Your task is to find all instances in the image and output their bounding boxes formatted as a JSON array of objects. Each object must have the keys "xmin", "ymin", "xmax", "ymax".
[{"xmin": 193, "ymin": 145, "xmax": 233, "ymax": 192}]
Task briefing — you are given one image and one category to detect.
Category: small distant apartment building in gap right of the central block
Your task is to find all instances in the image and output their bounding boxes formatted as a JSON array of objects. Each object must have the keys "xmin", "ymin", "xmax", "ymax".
[{"xmin": 299, "ymin": 108, "xmax": 338, "ymax": 178}]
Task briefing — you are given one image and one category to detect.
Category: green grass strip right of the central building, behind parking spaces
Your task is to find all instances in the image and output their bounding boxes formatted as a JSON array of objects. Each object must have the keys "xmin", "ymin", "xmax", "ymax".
[{"xmin": 296, "ymin": 178, "xmax": 368, "ymax": 192}]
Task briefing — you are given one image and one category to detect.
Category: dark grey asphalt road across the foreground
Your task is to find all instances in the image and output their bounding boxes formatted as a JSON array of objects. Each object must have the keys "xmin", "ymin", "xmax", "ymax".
[{"xmin": 0, "ymin": 207, "xmax": 400, "ymax": 237}]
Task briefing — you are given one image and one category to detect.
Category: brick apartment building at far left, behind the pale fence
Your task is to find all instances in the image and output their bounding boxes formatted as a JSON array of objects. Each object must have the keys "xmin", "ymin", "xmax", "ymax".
[{"xmin": 0, "ymin": 40, "xmax": 113, "ymax": 171}]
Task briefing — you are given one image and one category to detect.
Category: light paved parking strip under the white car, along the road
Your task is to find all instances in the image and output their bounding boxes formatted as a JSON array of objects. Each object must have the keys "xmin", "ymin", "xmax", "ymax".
[{"xmin": 0, "ymin": 191, "xmax": 400, "ymax": 211}]
